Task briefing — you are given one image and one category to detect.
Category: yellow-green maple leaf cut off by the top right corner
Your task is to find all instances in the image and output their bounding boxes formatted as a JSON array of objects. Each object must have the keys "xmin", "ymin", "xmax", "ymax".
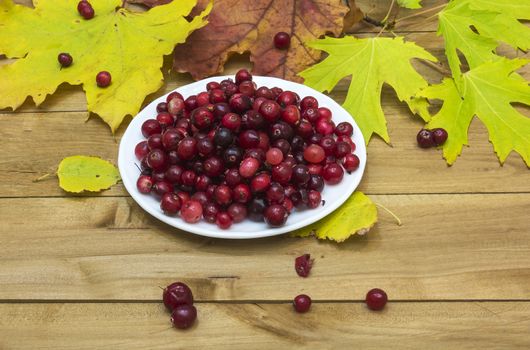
[{"xmin": 438, "ymin": 0, "xmax": 530, "ymax": 80}]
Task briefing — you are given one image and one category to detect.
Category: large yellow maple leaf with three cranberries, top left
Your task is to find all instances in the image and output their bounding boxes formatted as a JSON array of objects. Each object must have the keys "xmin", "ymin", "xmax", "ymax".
[{"xmin": 0, "ymin": 0, "xmax": 211, "ymax": 132}]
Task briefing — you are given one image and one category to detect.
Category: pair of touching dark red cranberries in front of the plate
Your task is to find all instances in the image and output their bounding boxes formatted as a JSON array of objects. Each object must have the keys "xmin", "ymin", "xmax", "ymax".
[{"xmin": 162, "ymin": 282, "xmax": 197, "ymax": 329}]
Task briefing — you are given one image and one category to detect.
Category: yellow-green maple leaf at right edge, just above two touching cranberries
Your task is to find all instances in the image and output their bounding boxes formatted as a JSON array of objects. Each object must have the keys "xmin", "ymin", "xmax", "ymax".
[{"xmin": 419, "ymin": 58, "xmax": 530, "ymax": 167}]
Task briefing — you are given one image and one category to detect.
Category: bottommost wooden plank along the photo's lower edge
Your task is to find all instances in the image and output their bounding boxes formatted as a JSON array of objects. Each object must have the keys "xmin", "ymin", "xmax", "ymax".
[{"xmin": 0, "ymin": 302, "xmax": 530, "ymax": 350}]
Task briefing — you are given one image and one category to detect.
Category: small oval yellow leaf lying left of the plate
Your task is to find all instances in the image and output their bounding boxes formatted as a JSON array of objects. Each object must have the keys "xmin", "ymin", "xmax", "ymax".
[{"xmin": 57, "ymin": 156, "xmax": 120, "ymax": 193}]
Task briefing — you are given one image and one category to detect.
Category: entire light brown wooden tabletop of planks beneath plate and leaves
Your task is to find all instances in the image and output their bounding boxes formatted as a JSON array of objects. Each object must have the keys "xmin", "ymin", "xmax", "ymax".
[{"xmin": 0, "ymin": 0, "xmax": 530, "ymax": 349}]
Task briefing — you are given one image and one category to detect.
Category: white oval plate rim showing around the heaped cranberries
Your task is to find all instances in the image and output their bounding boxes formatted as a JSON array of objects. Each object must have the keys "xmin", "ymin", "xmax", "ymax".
[{"xmin": 118, "ymin": 76, "xmax": 366, "ymax": 239}]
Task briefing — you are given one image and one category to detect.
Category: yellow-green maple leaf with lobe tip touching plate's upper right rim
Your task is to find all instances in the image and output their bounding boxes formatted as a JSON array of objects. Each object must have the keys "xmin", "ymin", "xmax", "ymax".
[{"xmin": 300, "ymin": 36, "xmax": 436, "ymax": 143}]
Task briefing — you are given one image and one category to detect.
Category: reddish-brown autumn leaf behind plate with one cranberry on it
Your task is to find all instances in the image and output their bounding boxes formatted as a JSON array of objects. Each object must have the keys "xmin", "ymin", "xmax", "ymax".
[{"xmin": 131, "ymin": 0, "xmax": 358, "ymax": 81}]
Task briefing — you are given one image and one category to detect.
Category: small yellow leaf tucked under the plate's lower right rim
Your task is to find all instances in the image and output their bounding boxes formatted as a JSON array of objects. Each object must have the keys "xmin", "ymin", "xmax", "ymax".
[{"xmin": 291, "ymin": 191, "xmax": 377, "ymax": 242}]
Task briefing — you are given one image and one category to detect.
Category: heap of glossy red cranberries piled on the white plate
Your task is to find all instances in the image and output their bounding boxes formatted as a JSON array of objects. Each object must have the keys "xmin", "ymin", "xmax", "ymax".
[{"xmin": 135, "ymin": 69, "xmax": 359, "ymax": 229}]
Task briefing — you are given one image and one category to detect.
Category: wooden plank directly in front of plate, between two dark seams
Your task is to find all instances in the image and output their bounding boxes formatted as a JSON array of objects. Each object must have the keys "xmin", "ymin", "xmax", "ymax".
[{"xmin": 0, "ymin": 194, "xmax": 530, "ymax": 300}]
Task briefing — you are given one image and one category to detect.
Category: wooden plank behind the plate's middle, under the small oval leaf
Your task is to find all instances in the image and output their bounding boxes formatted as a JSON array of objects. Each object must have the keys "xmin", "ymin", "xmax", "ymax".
[{"xmin": 0, "ymin": 107, "xmax": 530, "ymax": 197}]
